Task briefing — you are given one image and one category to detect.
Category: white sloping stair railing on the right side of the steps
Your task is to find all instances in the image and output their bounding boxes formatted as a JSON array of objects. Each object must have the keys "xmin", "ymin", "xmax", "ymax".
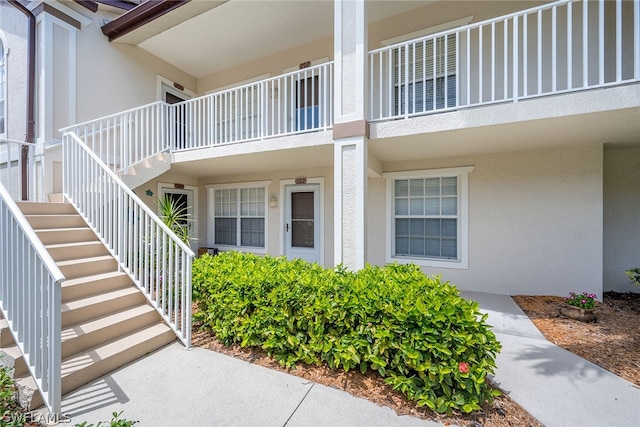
[{"xmin": 62, "ymin": 132, "xmax": 194, "ymax": 348}]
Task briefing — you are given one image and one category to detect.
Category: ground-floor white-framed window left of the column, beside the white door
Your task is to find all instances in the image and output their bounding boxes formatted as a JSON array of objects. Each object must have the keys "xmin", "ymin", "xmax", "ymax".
[{"xmin": 209, "ymin": 184, "xmax": 267, "ymax": 249}]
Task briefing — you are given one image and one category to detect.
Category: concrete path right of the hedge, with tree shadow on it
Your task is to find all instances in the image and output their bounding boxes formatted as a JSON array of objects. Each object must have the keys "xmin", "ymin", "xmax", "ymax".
[{"xmin": 462, "ymin": 292, "xmax": 640, "ymax": 427}]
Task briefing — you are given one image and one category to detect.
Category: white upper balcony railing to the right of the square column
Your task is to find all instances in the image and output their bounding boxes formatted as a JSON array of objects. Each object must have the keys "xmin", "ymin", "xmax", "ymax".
[{"xmin": 369, "ymin": 0, "xmax": 640, "ymax": 120}]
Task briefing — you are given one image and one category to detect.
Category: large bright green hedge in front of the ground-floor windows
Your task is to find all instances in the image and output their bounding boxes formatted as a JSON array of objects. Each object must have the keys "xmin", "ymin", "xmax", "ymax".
[{"xmin": 193, "ymin": 252, "xmax": 500, "ymax": 413}]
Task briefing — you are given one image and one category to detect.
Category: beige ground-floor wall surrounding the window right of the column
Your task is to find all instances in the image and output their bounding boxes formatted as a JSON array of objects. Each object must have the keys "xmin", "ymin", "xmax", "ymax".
[{"xmin": 368, "ymin": 145, "xmax": 603, "ymax": 296}]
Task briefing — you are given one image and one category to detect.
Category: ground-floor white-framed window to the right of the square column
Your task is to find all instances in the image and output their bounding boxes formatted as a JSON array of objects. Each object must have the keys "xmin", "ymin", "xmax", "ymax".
[{"xmin": 385, "ymin": 167, "xmax": 472, "ymax": 268}]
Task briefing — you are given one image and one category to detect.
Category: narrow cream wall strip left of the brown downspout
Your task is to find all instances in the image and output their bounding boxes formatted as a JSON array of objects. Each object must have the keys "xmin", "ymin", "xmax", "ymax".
[{"xmin": 0, "ymin": 2, "xmax": 29, "ymax": 141}]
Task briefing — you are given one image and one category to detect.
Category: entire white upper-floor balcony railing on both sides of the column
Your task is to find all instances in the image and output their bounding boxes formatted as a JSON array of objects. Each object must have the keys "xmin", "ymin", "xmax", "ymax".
[{"xmin": 64, "ymin": 0, "xmax": 640, "ymax": 176}]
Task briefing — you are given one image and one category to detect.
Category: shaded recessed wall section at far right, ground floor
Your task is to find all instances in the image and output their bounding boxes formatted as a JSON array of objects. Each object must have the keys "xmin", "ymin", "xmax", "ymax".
[{"xmin": 604, "ymin": 146, "xmax": 640, "ymax": 292}]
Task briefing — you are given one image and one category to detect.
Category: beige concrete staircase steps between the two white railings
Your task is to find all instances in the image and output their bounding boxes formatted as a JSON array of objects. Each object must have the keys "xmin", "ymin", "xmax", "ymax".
[{"xmin": 0, "ymin": 202, "xmax": 176, "ymax": 408}]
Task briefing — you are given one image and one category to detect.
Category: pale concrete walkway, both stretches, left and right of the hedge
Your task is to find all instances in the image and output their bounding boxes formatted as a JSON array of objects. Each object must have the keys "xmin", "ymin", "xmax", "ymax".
[{"xmin": 50, "ymin": 292, "xmax": 640, "ymax": 427}]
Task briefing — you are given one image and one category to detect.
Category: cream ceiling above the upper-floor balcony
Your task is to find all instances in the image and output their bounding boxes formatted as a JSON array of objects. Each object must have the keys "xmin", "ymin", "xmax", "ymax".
[{"xmin": 116, "ymin": 0, "xmax": 434, "ymax": 78}]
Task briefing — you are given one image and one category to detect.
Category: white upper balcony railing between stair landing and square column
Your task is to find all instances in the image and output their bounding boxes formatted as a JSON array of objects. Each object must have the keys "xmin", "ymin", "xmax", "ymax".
[{"xmin": 169, "ymin": 62, "xmax": 333, "ymax": 150}]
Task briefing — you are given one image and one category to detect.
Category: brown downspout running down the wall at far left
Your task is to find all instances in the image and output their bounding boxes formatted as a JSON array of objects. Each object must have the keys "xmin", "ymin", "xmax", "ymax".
[{"xmin": 9, "ymin": 0, "xmax": 36, "ymax": 200}]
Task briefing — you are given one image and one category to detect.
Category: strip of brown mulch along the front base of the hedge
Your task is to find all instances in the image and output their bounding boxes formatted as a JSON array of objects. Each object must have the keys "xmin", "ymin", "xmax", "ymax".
[{"xmin": 192, "ymin": 305, "xmax": 542, "ymax": 427}]
